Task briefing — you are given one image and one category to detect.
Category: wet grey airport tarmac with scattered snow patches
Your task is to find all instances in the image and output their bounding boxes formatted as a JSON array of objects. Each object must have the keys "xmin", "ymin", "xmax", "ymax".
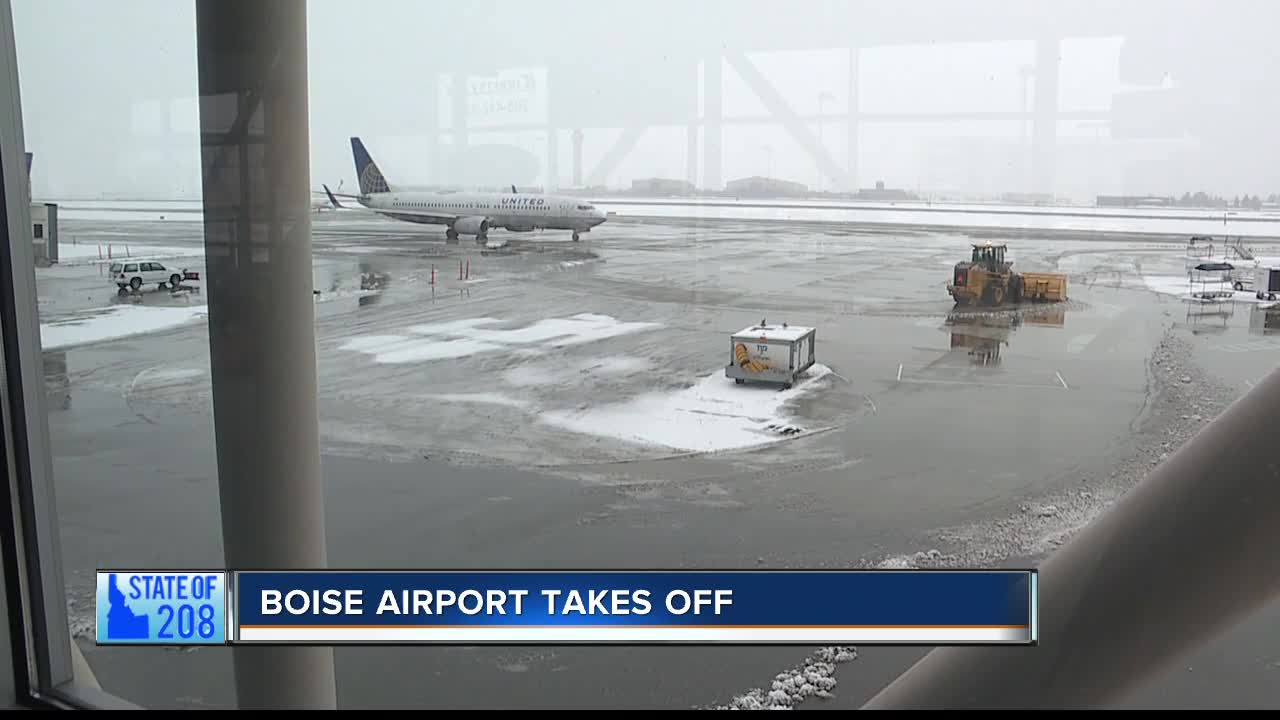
[{"xmin": 37, "ymin": 208, "xmax": 1280, "ymax": 708}]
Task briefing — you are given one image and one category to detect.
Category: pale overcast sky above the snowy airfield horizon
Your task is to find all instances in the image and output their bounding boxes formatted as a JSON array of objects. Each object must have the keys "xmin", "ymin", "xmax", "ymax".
[{"xmin": 13, "ymin": 0, "xmax": 1280, "ymax": 199}]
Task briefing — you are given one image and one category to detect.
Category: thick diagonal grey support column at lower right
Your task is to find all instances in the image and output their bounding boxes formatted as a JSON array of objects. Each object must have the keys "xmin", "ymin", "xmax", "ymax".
[{"xmin": 865, "ymin": 363, "xmax": 1280, "ymax": 710}]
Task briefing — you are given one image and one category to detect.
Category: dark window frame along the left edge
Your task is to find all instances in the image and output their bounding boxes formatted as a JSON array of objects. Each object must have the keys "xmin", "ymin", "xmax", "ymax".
[{"xmin": 0, "ymin": 0, "xmax": 137, "ymax": 710}]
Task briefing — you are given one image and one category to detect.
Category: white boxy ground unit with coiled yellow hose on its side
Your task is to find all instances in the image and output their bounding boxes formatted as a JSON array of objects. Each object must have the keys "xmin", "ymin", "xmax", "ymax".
[{"xmin": 724, "ymin": 323, "xmax": 818, "ymax": 387}]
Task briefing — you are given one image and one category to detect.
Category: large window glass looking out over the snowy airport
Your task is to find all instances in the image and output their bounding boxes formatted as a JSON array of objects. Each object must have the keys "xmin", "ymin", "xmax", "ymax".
[{"xmin": 10, "ymin": 0, "xmax": 1280, "ymax": 708}]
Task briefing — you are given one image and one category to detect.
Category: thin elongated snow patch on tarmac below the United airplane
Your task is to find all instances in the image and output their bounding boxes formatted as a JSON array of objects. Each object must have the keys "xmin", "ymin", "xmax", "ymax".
[{"xmin": 340, "ymin": 313, "xmax": 658, "ymax": 364}]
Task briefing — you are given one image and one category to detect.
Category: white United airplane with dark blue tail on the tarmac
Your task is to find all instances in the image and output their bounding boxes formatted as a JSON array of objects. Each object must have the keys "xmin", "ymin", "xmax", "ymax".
[{"xmin": 335, "ymin": 137, "xmax": 607, "ymax": 247}]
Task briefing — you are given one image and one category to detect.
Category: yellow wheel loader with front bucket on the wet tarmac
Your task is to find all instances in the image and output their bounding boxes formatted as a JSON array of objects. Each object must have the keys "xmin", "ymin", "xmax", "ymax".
[{"xmin": 947, "ymin": 242, "xmax": 1066, "ymax": 307}]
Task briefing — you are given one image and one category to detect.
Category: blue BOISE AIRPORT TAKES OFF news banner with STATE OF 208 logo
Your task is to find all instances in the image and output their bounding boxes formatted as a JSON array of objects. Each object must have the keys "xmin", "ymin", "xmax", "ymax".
[{"xmin": 97, "ymin": 570, "xmax": 1037, "ymax": 646}]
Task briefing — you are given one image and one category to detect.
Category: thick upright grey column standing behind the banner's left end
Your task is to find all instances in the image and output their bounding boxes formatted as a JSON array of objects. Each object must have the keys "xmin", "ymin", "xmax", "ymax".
[{"xmin": 196, "ymin": 0, "xmax": 337, "ymax": 708}]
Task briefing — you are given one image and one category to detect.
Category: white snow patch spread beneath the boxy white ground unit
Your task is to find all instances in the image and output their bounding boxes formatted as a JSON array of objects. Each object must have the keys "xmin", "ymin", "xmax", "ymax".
[{"xmin": 540, "ymin": 365, "xmax": 831, "ymax": 452}]
